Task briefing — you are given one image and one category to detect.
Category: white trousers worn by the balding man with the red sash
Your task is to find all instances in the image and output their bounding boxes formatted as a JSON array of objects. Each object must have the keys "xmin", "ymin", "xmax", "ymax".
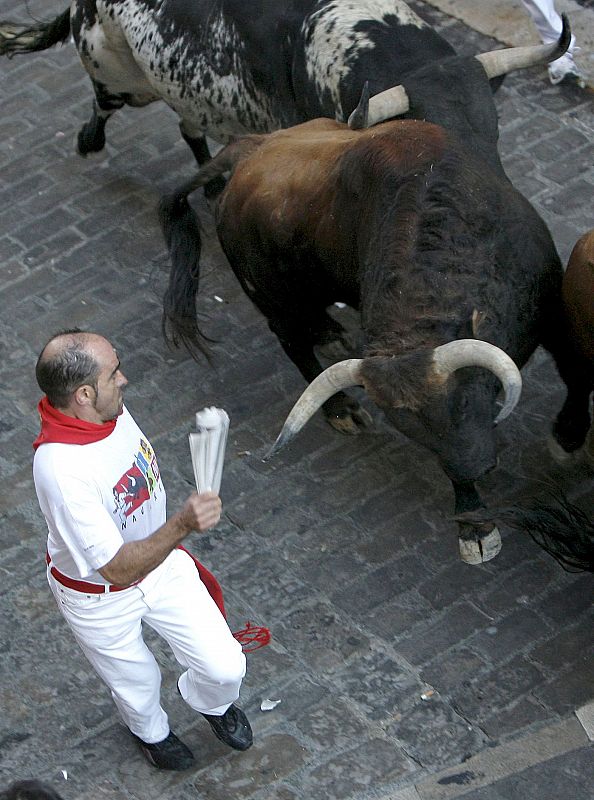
[{"xmin": 48, "ymin": 550, "xmax": 246, "ymax": 743}]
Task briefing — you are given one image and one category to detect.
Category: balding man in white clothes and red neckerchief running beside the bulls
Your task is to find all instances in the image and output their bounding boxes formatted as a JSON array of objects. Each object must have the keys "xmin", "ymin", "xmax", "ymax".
[{"xmin": 33, "ymin": 329, "xmax": 252, "ymax": 770}]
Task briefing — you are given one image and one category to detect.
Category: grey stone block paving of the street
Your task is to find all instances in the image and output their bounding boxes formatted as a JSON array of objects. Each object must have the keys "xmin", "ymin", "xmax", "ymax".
[{"xmin": 0, "ymin": 0, "xmax": 594, "ymax": 800}]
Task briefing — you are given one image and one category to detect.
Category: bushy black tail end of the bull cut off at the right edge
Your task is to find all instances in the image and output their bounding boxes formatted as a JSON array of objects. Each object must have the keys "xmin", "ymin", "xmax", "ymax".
[{"xmin": 456, "ymin": 493, "xmax": 594, "ymax": 572}]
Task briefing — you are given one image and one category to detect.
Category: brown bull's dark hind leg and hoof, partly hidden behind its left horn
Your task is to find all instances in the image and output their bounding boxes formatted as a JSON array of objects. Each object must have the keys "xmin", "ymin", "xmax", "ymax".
[{"xmin": 268, "ymin": 319, "xmax": 372, "ymax": 434}]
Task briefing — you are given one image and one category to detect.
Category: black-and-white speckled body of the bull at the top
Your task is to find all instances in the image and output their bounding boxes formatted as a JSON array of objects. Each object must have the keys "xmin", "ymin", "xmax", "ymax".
[{"xmin": 0, "ymin": 0, "xmax": 560, "ymax": 194}]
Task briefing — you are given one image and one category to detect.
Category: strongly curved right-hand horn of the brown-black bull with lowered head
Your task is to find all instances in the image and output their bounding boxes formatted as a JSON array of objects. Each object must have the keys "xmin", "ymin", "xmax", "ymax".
[{"xmin": 433, "ymin": 339, "xmax": 522, "ymax": 425}]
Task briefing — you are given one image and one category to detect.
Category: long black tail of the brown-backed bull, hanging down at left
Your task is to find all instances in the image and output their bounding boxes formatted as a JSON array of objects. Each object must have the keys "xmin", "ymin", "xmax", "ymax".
[{"xmin": 159, "ymin": 135, "xmax": 264, "ymax": 358}]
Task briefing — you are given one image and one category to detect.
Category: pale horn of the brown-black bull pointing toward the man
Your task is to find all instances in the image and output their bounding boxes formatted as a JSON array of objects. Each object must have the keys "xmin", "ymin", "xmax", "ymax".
[{"xmin": 264, "ymin": 358, "xmax": 363, "ymax": 461}]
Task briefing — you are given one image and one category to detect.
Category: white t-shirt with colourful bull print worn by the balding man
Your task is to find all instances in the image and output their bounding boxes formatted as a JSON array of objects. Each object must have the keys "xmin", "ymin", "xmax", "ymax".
[{"xmin": 33, "ymin": 407, "xmax": 166, "ymax": 583}]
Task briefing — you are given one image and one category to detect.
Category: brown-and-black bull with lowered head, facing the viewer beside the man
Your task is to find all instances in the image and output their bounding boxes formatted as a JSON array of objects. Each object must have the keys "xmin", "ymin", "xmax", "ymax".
[{"xmin": 161, "ymin": 23, "xmax": 590, "ymax": 563}]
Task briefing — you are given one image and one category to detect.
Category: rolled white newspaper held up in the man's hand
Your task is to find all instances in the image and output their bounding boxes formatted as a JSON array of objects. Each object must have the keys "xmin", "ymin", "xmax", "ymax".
[{"xmin": 188, "ymin": 406, "xmax": 229, "ymax": 494}]
